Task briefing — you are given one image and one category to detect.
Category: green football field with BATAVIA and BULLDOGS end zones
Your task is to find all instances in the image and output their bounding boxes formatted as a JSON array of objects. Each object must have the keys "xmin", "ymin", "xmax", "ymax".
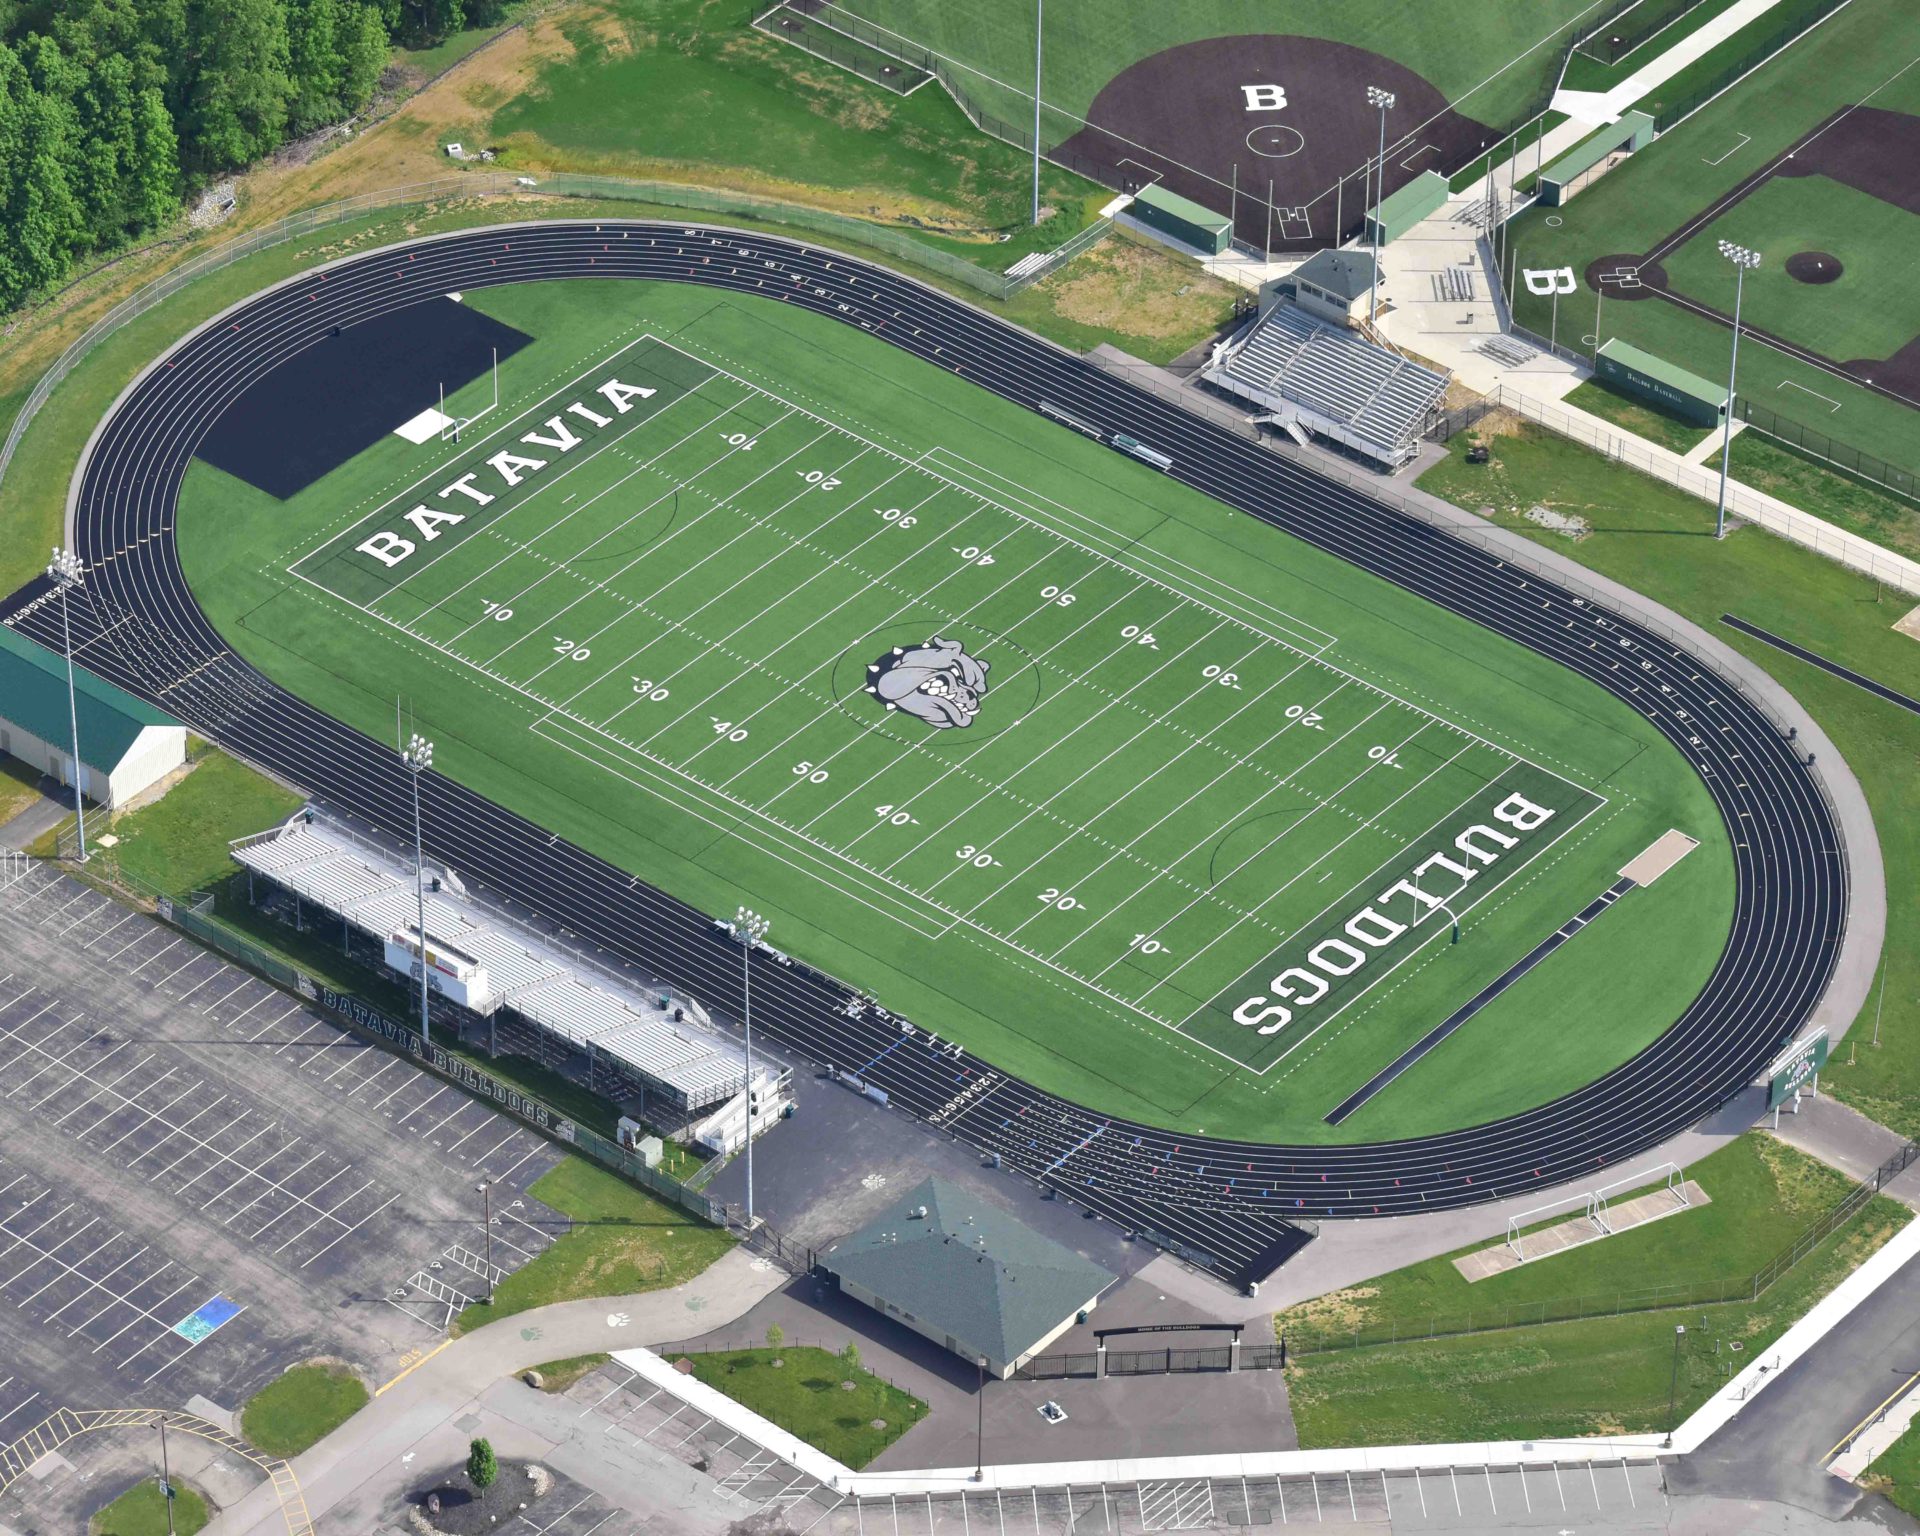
[{"xmin": 290, "ymin": 336, "xmax": 1605, "ymax": 1069}]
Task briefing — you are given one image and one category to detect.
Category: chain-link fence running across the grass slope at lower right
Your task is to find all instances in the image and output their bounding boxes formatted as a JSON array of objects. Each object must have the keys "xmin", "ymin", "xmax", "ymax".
[{"xmin": 1284, "ymin": 1142, "xmax": 1920, "ymax": 1356}]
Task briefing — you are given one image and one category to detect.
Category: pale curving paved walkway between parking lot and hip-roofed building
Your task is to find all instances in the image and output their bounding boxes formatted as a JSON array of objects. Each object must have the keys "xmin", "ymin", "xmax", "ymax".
[{"xmin": 207, "ymin": 1248, "xmax": 787, "ymax": 1536}]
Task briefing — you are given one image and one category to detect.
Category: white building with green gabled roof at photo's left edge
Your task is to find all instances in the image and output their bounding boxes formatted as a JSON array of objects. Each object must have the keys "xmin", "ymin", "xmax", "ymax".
[{"xmin": 0, "ymin": 624, "xmax": 186, "ymax": 810}]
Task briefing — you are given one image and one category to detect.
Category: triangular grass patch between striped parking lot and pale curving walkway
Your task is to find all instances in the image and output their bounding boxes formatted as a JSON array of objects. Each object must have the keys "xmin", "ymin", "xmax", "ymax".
[{"xmin": 453, "ymin": 1158, "xmax": 733, "ymax": 1334}]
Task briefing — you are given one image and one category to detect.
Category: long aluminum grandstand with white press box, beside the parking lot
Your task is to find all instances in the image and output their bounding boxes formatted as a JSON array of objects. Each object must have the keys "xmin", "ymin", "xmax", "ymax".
[{"xmin": 232, "ymin": 814, "xmax": 778, "ymax": 1137}]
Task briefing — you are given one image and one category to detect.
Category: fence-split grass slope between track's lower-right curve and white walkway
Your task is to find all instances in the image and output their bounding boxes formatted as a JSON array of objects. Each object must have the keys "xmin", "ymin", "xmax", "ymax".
[{"xmin": 1277, "ymin": 1131, "xmax": 1912, "ymax": 1448}]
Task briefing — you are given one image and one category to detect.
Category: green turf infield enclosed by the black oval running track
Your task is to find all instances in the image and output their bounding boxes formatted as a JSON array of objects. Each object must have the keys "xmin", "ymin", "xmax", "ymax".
[{"xmin": 180, "ymin": 282, "xmax": 1730, "ymax": 1140}]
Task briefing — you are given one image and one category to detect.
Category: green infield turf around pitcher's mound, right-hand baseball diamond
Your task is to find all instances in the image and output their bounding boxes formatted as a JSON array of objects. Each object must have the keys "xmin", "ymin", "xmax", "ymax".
[{"xmin": 1661, "ymin": 177, "xmax": 1920, "ymax": 362}]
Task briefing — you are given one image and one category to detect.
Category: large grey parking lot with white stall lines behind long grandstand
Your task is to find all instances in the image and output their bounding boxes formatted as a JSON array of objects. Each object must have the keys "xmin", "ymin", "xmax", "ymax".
[{"xmin": 0, "ymin": 866, "xmax": 564, "ymax": 1440}]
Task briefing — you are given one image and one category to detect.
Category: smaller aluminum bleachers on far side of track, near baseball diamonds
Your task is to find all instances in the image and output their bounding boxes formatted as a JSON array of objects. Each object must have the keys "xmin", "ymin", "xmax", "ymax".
[{"xmin": 1202, "ymin": 300, "xmax": 1448, "ymax": 470}]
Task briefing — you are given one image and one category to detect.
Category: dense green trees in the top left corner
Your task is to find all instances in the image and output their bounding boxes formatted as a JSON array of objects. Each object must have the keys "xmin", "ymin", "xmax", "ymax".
[{"xmin": 0, "ymin": 0, "xmax": 507, "ymax": 309}]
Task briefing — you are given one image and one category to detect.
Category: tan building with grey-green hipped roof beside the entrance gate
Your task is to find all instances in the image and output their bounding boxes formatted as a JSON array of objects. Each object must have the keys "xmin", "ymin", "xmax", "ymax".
[{"xmin": 820, "ymin": 1179, "xmax": 1116, "ymax": 1380}]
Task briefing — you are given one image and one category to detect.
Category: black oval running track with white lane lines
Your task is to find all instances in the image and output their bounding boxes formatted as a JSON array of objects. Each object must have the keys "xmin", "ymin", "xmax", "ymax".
[{"xmin": 8, "ymin": 223, "xmax": 1847, "ymax": 1279}]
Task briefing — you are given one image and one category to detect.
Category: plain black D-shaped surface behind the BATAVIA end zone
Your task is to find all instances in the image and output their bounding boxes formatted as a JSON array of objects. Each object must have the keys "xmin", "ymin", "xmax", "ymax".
[{"xmin": 198, "ymin": 286, "xmax": 534, "ymax": 501}]
